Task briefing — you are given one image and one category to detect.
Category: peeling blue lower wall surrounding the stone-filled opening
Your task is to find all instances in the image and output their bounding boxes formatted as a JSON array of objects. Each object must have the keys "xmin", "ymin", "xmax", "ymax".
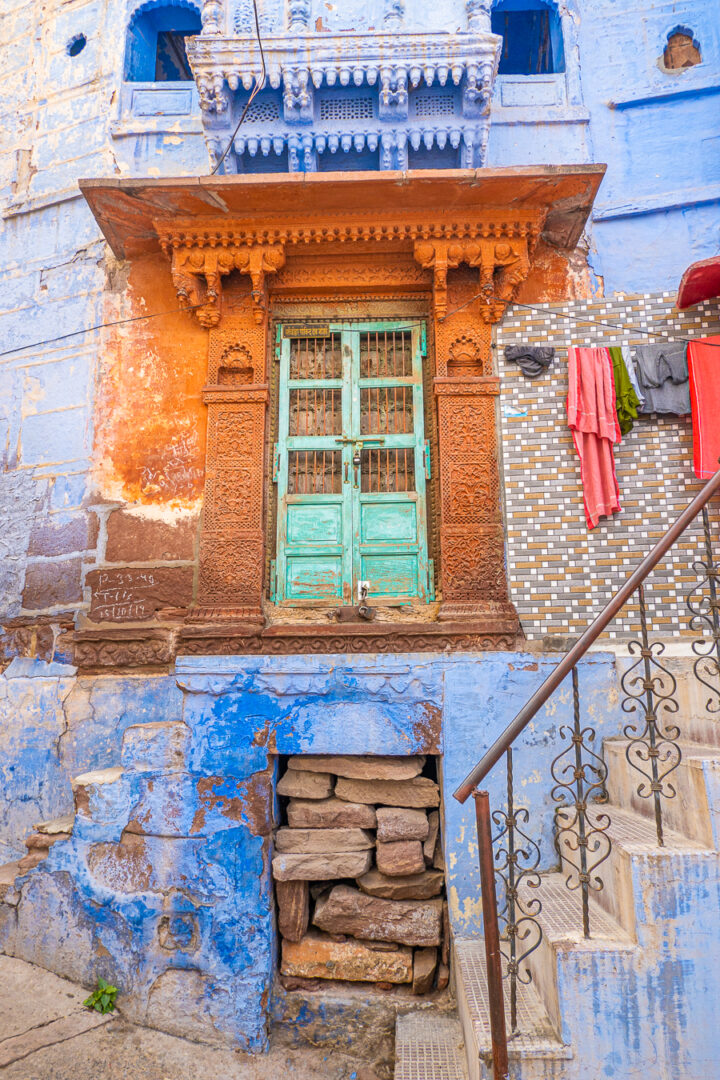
[{"xmin": 0, "ymin": 653, "xmax": 620, "ymax": 1050}]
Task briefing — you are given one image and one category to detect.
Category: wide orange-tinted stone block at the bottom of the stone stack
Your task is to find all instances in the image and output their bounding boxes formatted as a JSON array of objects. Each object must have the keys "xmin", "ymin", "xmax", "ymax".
[{"xmin": 281, "ymin": 933, "xmax": 412, "ymax": 983}]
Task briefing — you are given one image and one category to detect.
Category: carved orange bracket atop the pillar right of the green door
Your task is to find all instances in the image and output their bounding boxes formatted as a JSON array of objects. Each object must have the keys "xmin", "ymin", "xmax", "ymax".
[{"xmin": 415, "ymin": 233, "xmax": 530, "ymax": 323}]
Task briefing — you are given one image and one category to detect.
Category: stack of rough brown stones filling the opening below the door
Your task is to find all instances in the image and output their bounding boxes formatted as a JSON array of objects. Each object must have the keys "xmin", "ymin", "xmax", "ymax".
[{"xmin": 272, "ymin": 755, "xmax": 449, "ymax": 994}]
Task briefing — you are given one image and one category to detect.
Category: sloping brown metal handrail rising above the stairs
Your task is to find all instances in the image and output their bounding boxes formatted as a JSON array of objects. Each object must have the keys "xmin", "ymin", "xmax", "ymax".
[{"xmin": 453, "ymin": 469, "xmax": 720, "ymax": 802}]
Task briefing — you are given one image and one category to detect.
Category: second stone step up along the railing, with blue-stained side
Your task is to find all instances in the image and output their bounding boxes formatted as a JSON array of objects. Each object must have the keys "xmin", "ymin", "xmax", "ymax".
[{"xmin": 519, "ymin": 873, "xmax": 638, "ymax": 1043}]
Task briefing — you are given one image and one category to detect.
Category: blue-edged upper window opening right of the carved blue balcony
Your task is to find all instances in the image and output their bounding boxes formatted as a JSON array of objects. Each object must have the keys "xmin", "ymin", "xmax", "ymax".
[{"xmin": 491, "ymin": 0, "xmax": 565, "ymax": 75}]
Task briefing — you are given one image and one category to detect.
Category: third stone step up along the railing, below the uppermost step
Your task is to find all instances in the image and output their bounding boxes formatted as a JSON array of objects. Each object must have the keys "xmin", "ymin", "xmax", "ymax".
[{"xmin": 558, "ymin": 802, "xmax": 718, "ymax": 940}]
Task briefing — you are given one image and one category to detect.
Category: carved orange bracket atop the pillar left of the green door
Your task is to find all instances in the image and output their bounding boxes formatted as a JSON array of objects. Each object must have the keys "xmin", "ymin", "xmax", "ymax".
[{"xmin": 165, "ymin": 240, "xmax": 285, "ymax": 328}]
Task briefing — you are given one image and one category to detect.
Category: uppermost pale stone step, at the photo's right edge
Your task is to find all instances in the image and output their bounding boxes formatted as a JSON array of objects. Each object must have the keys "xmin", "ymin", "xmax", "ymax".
[{"xmin": 603, "ymin": 739, "xmax": 720, "ymax": 851}]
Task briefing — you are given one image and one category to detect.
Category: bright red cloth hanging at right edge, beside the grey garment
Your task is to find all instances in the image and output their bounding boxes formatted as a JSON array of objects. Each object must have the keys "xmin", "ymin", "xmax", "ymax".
[{"xmin": 688, "ymin": 337, "xmax": 720, "ymax": 480}]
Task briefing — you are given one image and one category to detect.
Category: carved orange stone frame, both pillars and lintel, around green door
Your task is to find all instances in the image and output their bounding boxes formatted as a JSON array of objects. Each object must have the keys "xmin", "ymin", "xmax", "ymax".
[{"xmin": 158, "ymin": 217, "xmax": 540, "ymax": 633}]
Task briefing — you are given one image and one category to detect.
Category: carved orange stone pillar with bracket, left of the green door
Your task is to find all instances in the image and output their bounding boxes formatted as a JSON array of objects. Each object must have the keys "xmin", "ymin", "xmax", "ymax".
[{"xmin": 164, "ymin": 238, "xmax": 285, "ymax": 624}]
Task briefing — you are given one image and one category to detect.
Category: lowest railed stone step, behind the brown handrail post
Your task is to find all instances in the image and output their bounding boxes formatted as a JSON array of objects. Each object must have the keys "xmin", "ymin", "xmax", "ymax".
[{"xmin": 454, "ymin": 940, "xmax": 572, "ymax": 1080}]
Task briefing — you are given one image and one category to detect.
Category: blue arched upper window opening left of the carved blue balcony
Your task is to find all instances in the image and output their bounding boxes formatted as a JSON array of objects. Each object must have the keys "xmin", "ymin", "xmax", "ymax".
[{"xmin": 125, "ymin": 0, "xmax": 202, "ymax": 82}]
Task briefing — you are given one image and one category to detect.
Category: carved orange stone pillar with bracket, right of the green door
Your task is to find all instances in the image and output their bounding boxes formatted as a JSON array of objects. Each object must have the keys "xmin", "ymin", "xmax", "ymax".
[{"xmin": 415, "ymin": 236, "xmax": 529, "ymax": 620}]
